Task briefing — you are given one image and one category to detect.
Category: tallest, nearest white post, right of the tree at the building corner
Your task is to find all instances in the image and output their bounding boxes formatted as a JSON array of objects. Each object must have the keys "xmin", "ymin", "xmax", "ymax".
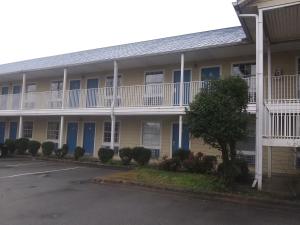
[{"xmin": 256, "ymin": 9, "xmax": 264, "ymax": 190}]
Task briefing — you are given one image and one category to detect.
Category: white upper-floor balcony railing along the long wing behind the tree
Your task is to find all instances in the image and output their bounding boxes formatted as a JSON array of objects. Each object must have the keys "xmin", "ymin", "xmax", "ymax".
[{"xmin": 0, "ymin": 77, "xmax": 256, "ymax": 110}]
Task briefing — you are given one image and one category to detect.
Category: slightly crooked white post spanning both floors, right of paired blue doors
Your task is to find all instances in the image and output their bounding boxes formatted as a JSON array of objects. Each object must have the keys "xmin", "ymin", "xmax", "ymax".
[{"xmin": 110, "ymin": 61, "xmax": 118, "ymax": 150}]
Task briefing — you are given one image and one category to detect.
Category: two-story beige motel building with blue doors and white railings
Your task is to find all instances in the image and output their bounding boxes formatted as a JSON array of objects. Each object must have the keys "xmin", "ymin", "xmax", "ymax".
[{"xmin": 0, "ymin": 0, "xmax": 300, "ymax": 186}]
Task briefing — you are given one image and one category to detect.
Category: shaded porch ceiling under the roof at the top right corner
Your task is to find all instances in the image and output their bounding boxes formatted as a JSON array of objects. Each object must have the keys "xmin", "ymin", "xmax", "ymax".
[{"xmin": 264, "ymin": 4, "xmax": 300, "ymax": 43}]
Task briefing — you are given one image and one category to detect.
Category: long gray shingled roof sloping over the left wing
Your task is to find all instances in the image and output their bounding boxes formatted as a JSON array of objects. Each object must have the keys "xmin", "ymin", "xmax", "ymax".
[{"xmin": 0, "ymin": 27, "xmax": 246, "ymax": 74}]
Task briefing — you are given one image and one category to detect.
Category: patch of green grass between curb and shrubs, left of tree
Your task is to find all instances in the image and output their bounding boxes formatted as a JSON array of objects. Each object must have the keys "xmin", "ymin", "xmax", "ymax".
[{"xmin": 101, "ymin": 168, "xmax": 227, "ymax": 192}]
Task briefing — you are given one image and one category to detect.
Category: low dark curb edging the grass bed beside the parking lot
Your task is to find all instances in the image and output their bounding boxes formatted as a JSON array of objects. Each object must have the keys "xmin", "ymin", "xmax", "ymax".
[{"xmin": 92, "ymin": 178, "xmax": 300, "ymax": 210}]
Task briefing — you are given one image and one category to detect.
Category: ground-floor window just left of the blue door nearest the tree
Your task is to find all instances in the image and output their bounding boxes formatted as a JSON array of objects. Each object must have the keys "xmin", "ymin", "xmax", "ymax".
[{"xmin": 142, "ymin": 122, "xmax": 160, "ymax": 150}]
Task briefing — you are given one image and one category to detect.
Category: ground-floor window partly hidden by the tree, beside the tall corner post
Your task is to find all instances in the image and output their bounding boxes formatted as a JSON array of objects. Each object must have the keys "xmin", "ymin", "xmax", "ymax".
[{"xmin": 236, "ymin": 118, "xmax": 256, "ymax": 165}]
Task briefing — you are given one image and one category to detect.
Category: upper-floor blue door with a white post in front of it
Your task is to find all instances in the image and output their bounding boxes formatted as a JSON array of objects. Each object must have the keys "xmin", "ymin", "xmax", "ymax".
[{"xmin": 173, "ymin": 70, "xmax": 191, "ymax": 105}]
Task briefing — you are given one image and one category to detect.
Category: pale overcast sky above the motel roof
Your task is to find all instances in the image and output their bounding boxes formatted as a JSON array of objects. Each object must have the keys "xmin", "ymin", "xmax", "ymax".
[{"xmin": 0, "ymin": 0, "xmax": 240, "ymax": 64}]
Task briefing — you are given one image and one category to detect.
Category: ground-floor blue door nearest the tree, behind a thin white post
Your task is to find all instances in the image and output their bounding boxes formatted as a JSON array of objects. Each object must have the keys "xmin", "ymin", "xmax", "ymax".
[{"xmin": 172, "ymin": 123, "xmax": 190, "ymax": 152}]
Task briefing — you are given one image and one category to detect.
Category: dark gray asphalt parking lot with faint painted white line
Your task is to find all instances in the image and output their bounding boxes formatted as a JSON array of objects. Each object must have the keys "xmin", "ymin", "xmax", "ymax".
[{"xmin": 0, "ymin": 159, "xmax": 300, "ymax": 225}]
